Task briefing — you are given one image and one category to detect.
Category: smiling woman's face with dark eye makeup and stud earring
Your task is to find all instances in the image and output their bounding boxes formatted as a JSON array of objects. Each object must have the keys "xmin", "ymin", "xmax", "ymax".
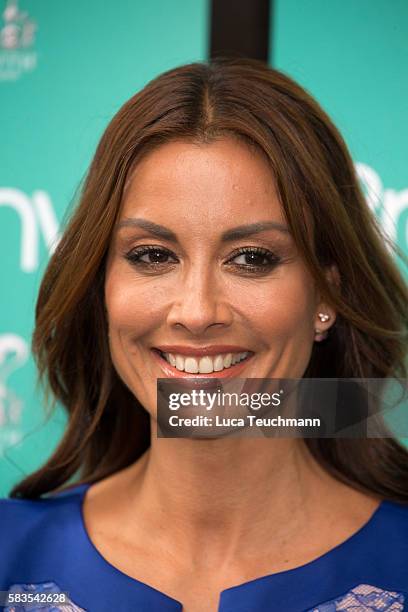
[{"xmin": 105, "ymin": 139, "xmax": 335, "ymax": 415}]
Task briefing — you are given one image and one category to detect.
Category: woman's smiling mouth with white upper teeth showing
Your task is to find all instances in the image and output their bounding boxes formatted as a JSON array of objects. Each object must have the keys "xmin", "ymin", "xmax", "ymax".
[{"xmin": 151, "ymin": 348, "xmax": 254, "ymax": 376}]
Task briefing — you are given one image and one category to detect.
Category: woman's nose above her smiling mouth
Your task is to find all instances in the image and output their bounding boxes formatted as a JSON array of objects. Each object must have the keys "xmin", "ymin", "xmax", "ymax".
[{"xmin": 167, "ymin": 261, "xmax": 233, "ymax": 336}]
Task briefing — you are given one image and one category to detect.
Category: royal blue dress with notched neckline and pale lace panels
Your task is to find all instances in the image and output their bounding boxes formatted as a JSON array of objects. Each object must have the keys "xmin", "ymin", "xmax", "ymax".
[{"xmin": 0, "ymin": 483, "xmax": 408, "ymax": 612}]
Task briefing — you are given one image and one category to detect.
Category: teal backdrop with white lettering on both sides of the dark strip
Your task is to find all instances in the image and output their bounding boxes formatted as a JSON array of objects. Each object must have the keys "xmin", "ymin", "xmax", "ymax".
[{"xmin": 0, "ymin": 0, "xmax": 408, "ymax": 496}]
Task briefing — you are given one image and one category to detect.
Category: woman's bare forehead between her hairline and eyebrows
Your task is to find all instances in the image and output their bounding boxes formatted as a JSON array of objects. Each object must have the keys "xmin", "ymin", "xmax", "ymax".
[{"xmin": 120, "ymin": 138, "xmax": 284, "ymax": 230}]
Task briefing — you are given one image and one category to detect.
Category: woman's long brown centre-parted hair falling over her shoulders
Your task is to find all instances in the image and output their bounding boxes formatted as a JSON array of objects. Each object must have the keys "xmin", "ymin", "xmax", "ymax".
[{"xmin": 10, "ymin": 58, "xmax": 408, "ymax": 503}]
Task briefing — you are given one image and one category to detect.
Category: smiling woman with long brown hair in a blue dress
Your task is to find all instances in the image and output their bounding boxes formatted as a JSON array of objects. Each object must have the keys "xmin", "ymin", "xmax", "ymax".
[{"xmin": 0, "ymin": 59, "xmax": 408, "ymax": 612}]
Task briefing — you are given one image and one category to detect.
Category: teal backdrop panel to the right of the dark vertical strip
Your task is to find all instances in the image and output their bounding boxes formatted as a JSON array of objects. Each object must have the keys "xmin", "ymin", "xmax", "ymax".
[{"xmin": 271, "ymin": 0, "xmax": 408, "ymax": 260}]
